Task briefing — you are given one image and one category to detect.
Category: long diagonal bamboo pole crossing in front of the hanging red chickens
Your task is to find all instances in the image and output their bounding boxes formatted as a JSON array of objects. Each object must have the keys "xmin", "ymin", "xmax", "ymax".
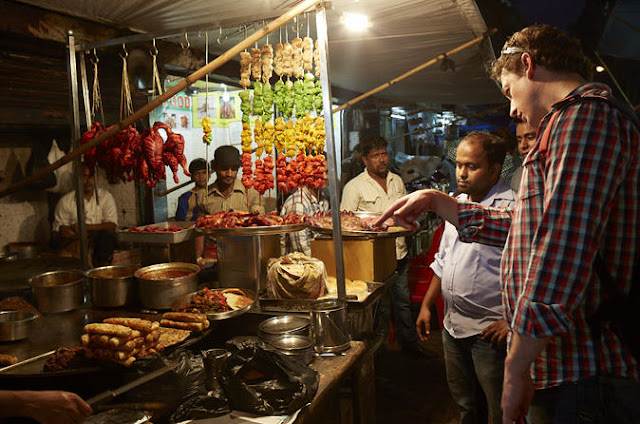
[{"xmin": 0, "ymin": 0, "xmax": 321, "ymax": 197}]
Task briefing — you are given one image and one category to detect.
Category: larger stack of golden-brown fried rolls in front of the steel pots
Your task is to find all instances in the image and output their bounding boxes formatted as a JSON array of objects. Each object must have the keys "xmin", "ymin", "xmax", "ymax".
[{"xmin": 81, "ymin": 318, "xmax": 162, "ymax": 367}]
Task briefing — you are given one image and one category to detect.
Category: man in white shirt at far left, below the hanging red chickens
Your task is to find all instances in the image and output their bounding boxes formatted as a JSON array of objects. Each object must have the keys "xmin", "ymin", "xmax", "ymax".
[{"xmin": 53, "ymin": 165, "xmax": 118, "ymax": 266}]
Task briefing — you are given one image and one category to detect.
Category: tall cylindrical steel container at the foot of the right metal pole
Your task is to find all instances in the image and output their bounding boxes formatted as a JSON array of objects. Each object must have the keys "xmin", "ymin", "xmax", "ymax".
[{"xmin": 310, "ymin": 299, "xmax": 351, "ymax": 353}]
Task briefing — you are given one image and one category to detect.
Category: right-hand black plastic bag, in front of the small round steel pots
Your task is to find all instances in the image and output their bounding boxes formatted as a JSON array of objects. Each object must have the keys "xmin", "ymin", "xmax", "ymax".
[{"xmin": 222, "ymin": 346, "xmax": 320, "ymax": 415}]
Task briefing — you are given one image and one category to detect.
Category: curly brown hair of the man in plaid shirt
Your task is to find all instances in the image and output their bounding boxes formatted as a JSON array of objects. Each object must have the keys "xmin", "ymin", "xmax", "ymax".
[{"xmin": 491, "ymin": 25, "xmax": 592, "ymax": 81}]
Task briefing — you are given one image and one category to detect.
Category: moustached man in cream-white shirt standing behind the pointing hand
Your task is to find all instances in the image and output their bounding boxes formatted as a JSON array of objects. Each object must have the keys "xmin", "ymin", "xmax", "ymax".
[{"xmin": 340, "ymin": 135, "xmax": 425, "ymax": 354}]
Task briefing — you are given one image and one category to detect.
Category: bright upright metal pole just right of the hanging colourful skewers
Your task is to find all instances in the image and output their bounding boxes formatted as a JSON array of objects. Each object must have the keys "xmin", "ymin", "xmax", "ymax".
[{"xmin": 316, "ymin": 3, "xmax": 347, "ymax": 300}]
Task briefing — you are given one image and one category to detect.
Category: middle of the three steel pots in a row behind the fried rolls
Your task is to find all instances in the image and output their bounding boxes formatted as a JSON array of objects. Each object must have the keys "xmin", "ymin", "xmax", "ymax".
[{"xmin": 87, "ymin": 265, "xmax": 136, "ymax": 308}]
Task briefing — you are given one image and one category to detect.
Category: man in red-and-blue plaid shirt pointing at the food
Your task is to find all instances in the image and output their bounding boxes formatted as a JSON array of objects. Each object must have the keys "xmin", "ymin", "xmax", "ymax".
[{"xmin": 381, "ymin": 25, "xmax": 640, "ymax": 424}]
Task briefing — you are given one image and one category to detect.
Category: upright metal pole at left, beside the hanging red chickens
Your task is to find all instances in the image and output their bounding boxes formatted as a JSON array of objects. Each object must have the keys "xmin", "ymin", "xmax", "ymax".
[{"xmin": 67, "ymin": 31, "xmax": 89, "ymax": 269}]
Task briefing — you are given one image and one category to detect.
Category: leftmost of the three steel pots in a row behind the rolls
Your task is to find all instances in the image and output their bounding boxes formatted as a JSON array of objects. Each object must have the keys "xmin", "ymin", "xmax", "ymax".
[{"xmin": 29, "ymin": 269, "xmax": 85, "ymax": 313}]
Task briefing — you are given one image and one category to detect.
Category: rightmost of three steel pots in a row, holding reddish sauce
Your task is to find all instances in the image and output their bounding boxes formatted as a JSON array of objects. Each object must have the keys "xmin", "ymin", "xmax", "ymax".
[{"xmin": 134, "ymin": 262, "xmax": 200, "ymax": 309}]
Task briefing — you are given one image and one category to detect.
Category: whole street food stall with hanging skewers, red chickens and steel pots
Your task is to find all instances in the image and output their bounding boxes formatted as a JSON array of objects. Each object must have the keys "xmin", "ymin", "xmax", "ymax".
[{"xmin": 0, "ymin": 0, "xmax": 508, "ymax": 423}]
